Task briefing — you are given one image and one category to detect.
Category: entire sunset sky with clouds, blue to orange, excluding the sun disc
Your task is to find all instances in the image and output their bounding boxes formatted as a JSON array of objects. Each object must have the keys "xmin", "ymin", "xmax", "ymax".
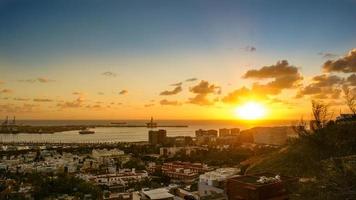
[{"xmin": 0, "ymin": 0, "xmax": 356, "ymax": 119}]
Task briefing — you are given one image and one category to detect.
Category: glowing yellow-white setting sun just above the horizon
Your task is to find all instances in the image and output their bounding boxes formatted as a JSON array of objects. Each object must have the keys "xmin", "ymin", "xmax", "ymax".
[{"xmin": 235, "ymin": 102, "xmax": 266, "ymax": 120}]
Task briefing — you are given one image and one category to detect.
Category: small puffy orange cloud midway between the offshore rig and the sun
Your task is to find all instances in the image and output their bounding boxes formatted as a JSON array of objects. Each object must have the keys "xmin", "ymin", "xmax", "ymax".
[{"xmin": 188, "ymin": 80, "xmax": 221, "ymax": 106}]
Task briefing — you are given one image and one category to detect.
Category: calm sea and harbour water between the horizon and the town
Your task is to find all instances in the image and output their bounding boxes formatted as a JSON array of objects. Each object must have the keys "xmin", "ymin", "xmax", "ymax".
[{"xmin": 0, "ymin": 120, "xmax": 295, "ymax": 143}]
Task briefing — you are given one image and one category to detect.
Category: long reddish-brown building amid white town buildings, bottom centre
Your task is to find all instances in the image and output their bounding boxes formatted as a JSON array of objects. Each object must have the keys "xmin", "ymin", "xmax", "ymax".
[{"xmin": 161, "ymin": 161, "xmax": 210, "ymax": 183}]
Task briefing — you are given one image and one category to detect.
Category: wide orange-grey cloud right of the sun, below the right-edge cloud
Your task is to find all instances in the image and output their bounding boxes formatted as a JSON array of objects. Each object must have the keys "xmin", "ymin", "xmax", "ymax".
[{"xmin": 296, "ymin": 74, "xmax": 344, "ymax": 99}]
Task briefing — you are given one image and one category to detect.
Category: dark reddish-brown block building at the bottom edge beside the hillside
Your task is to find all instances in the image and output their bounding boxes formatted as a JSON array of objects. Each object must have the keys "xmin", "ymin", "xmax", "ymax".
[{"xmin": 226, "ymin": 173, "xmax": 296, "ymax": 200}]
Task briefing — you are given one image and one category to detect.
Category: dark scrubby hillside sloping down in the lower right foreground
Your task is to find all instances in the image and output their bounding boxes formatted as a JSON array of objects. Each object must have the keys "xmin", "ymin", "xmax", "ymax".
[{"xmin": 247, "ymin": 123, "xmax": 356, "ymax": 199}]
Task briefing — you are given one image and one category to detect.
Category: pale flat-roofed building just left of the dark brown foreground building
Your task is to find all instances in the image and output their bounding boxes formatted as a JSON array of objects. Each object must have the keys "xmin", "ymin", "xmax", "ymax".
[{"xmin": 198, "ymin": 168, "xmax": 241, "ymax": 199}]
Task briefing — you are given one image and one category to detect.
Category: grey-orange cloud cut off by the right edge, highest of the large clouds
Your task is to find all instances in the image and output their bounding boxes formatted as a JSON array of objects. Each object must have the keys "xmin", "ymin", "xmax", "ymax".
[{"xmin": 323, "ymin": 49, "xmax": 356, "ymax": 73}]
